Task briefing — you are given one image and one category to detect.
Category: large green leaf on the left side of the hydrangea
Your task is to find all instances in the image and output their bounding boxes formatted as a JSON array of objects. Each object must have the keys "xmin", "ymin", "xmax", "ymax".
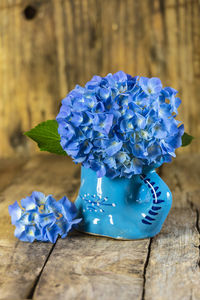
[{"xmin": 24, "ymin": 120, "xmax": 67, "ymax": 155}]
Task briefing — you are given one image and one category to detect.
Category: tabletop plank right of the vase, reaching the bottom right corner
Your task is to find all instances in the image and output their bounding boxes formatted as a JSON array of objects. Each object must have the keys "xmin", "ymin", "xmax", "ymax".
[{"xmin": 144, "ymin": 155, "xmax": 200, "ymax": 300}]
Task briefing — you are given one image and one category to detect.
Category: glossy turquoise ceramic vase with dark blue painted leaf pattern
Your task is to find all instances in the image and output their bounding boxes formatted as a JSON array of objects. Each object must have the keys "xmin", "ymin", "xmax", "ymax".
[{"xmin": 75, "ymin": 167, "xmax": 172, "ymax": 239}]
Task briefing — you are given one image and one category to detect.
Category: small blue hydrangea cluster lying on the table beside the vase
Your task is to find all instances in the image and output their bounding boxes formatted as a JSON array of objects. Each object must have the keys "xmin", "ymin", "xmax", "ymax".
[{"xmin": 9, "ymin": 191, "xmax": 81, "ymax": 243}]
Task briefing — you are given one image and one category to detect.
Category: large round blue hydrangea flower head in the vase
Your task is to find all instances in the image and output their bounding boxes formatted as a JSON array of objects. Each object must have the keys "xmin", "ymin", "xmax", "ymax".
[{"xmin": 56, "ymin": 71, "xmax": 184, "ymax": 178}]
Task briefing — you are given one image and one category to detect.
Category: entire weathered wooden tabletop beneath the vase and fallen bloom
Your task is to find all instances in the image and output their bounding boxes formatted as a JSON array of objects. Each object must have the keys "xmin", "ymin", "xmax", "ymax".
[{"xmin": 0, "ymin": 154, "xmax": 200, "ymax": 300}]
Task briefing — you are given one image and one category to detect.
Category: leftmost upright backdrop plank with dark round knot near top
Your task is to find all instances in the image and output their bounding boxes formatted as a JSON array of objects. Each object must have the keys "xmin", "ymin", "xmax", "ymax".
[{"xmin": 0, "ymin": 0, "xmax": 60, "ymax": 156}]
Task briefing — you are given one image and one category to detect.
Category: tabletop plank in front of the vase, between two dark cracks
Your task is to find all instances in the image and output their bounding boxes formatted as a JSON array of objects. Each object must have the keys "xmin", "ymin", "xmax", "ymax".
[{"xmin": 33, "ymin": 233, "xmax": 149, "ymax": 300}]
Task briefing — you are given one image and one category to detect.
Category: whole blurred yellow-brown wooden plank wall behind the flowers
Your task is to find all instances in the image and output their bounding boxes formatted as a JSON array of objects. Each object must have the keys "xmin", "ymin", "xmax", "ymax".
[{"xmin": 0, "ymin": 0, "xmax": 200, "ymax": 157}]
